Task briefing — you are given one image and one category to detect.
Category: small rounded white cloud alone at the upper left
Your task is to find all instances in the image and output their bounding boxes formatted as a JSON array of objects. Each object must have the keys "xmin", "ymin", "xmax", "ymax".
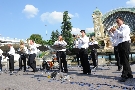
[{"xmin": 22, "ymin": 5, "xmax": 39, "ymax": 18}]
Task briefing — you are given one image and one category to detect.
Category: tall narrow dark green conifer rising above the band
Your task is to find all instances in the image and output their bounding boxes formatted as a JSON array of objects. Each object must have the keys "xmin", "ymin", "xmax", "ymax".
[{"xmin": 61, "ymin": 11, "xmax": 73, "ymax": 49}]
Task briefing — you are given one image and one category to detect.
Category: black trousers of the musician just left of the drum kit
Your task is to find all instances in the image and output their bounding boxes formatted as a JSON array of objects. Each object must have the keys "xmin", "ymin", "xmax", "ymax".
[{"xmin": 28, "ymin": 54, "xmax": 37, "ymax": 71}]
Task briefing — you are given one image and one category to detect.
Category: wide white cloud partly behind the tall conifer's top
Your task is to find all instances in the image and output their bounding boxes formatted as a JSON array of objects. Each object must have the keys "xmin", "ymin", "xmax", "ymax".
[{"xmin": 40, "ymin": 11, "xmax": 79, "ymax": 24}]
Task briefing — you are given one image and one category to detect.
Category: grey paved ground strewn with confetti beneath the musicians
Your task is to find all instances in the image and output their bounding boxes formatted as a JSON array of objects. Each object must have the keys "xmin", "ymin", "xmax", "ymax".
[{"xmin": 0, "ymin": 65, "xmax": 135, "ymax": 90}]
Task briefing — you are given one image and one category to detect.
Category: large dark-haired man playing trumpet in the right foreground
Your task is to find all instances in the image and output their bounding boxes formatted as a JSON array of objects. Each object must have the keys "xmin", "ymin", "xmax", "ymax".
[{"xmin": 110, "ymin": 17, "xmax": 133, "ymax": 82}]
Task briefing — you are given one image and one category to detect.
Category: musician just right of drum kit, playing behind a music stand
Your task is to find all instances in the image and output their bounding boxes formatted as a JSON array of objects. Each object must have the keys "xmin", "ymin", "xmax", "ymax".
[{"xmin": 54, "ymin": 35, "xmax": 68, "ymax": 73}]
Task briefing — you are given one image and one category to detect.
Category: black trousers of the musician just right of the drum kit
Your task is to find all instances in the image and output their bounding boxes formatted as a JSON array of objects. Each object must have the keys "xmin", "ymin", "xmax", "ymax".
[{"xmin": 56, "ymin": 51, "xmax": 68, "ymax": 71}]
